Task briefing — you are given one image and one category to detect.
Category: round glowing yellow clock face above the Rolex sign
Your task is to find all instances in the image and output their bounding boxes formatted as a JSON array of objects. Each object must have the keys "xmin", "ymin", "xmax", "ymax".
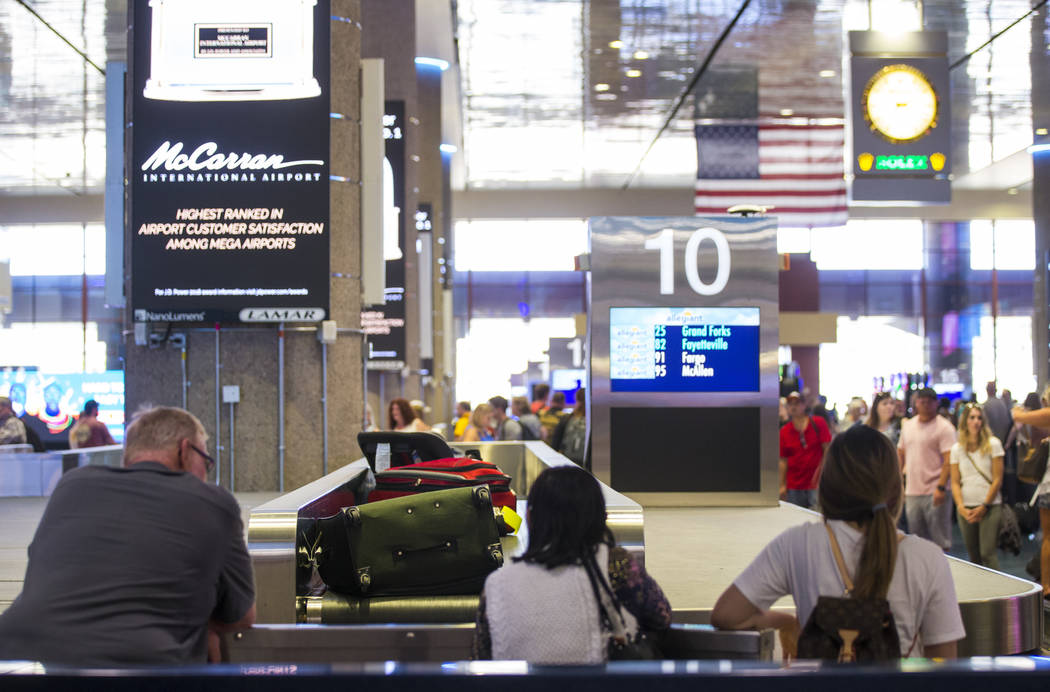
[{"xmin": 863, "ymin": 65, "xmax": 938, "ymax": 143}]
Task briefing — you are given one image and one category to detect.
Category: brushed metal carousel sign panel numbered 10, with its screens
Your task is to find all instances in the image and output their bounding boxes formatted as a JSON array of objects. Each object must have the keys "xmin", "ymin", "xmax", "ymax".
[{"xmin": 587, "ymin": 217, "xmax": 779, "ymax": 505}]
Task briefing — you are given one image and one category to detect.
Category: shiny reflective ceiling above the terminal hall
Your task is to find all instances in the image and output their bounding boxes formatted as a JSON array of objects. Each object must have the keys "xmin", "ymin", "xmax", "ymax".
[{"xmin": 0, "ymin": 0, "xmax": 1048, "ymax": 223}]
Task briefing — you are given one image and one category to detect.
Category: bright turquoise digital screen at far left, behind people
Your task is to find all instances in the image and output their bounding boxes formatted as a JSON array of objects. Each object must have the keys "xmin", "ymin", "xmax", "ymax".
[{"xmin": 0, "ymin": 370, "xmax": 124, "ymax": 449}]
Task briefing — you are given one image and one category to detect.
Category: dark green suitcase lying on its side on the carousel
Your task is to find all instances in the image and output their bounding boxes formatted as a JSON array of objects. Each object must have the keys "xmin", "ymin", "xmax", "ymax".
[{"xmin": 314, "ymin": 485, "xmax": 503, "ymax": 596}]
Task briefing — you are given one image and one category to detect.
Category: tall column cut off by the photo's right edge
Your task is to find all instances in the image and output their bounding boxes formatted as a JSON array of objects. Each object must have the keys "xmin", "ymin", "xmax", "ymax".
[{"xmin": 1031, "ymin": 6, "xmax": 1050, "ymax": 389}]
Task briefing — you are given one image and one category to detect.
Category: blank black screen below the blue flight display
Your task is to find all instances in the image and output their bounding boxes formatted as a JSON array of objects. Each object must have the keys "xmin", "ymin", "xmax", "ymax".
[{"xmin": 609, "ymin": 406, "xmax": 761, "ymax": 492}]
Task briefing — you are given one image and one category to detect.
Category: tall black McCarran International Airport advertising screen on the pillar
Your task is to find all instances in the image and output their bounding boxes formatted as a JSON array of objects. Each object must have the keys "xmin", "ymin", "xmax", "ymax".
[{"xmin": 126, "ymin": 0, "xmax": 333, "ymax": 322}]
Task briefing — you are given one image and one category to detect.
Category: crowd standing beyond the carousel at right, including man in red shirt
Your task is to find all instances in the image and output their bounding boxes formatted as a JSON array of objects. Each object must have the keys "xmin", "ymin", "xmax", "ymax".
[{"xmin": 780, "ymin": 382, "xmax": 1050, "ymax": 594}]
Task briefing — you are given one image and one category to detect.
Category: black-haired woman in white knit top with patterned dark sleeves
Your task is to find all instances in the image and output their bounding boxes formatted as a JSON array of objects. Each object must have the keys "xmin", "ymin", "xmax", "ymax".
[{"xmin": 474, "ymin": 466, "xmax": 671, "ymax": 664}]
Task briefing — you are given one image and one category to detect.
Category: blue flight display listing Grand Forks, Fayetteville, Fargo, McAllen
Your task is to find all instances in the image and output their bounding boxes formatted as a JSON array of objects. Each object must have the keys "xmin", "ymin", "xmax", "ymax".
[{"xmin": 609, "ymin": 308, "xmax": 759, "ymax": 392}]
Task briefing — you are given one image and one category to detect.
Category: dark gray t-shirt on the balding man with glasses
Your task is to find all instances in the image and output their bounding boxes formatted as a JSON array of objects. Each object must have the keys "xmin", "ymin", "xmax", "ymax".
[{"xmin": 0, "ymin": 462, "xmax": 255, "ymax": 666}]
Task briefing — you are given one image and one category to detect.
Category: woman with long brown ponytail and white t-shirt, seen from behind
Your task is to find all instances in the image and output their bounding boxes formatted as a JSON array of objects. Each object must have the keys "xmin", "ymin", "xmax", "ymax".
[{"xmin": 711, "ymin": 425, "xmax": 966, "ymax": 658}]
